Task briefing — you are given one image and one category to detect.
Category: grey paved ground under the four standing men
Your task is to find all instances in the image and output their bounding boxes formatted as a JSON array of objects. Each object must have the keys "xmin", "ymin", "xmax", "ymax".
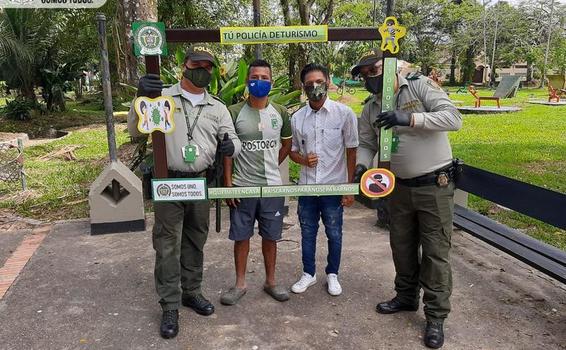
[{"xmin": 0, "ymin": 203, "xmax": 566, "ymax": 350}]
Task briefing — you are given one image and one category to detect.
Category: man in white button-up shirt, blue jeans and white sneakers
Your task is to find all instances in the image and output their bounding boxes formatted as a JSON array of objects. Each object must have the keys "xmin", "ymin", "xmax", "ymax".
[{"xmin": 290, "ymin": 63, "xmax": 358, "ymax": 296}]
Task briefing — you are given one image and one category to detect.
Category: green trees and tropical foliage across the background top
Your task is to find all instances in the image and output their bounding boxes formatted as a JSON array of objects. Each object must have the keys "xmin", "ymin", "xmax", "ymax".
[{"xmin": 0, "ymin": 0, "xmax": 566, "ymax": 118}]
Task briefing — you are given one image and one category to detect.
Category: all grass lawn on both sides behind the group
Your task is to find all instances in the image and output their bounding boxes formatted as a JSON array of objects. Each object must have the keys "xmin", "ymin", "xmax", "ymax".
[{"xmin": 0, "ymin": 88, "xmax": 566, "ymax": 250}]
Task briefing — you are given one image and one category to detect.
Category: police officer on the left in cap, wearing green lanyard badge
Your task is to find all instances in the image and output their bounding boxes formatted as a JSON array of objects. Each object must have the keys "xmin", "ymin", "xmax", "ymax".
[{"xmin": 128, "ymin": 46, "xmax": 241, "ymax": 338}]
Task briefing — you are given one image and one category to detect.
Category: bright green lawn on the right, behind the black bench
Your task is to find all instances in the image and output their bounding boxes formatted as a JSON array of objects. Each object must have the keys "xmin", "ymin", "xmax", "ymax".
[{"xmin": 302, "ymin": 88, "xmax": 566, "ymax": 250}]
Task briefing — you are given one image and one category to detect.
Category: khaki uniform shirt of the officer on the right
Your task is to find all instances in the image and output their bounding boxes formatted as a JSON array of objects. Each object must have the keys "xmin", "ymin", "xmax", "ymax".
[{"xmin": 357, "ymin": 74, "xmax": 462, "ymax": 179}]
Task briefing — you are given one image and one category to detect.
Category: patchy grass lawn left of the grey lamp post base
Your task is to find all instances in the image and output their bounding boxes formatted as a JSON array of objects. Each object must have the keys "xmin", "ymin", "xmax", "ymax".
[{"xmin": 0, "ymin": 124, "xmax": 129, "ymax": 220}]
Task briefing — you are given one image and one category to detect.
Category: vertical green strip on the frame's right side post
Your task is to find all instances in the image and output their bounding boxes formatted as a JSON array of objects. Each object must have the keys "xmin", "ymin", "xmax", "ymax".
[{"xmin": 379, "ymin": 57, "xmax": 397, "ymax": 162}]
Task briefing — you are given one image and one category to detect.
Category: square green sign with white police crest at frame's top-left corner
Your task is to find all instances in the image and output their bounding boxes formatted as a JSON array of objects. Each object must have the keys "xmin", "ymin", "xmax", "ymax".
[{"xmin": 132, "ymin": 21, "xmax": 167, "ymax": 56}]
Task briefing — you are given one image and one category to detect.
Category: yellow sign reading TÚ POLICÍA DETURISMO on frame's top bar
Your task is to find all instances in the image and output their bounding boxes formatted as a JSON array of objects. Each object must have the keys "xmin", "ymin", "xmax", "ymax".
[{"xmin": 220, "ymin": 25, "xmax": 328, "ymax": 45}]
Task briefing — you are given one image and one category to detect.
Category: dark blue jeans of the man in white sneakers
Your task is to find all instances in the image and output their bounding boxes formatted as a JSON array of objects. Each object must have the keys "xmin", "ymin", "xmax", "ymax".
[{"xmin": 297, "ymin": 196, "xmax": 344, "ymax": 276}]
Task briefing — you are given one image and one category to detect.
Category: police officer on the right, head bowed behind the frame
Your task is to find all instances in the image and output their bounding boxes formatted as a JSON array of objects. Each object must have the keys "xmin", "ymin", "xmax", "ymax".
[{"xmin": 352, "ymin": 50, "xmax": 462, "ymax": 348}]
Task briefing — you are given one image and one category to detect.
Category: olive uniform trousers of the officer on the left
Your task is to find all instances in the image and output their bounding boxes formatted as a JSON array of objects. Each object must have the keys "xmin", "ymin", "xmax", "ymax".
[{"xmin": 153, "ymin": 200, "xmax": 210, "ymax": 311}]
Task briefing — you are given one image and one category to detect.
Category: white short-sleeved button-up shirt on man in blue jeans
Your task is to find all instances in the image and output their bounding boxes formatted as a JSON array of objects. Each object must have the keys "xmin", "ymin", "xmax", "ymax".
[{"xmin": 291, "ymin": 97, "xmax": 358, "ymax": 185}]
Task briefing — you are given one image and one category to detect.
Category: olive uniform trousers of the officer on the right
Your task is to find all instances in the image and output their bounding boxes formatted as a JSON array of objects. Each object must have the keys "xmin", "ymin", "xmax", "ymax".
[{"xmin": 389, "ymin": 182, "xmax": 454, "ymax": 321}]
